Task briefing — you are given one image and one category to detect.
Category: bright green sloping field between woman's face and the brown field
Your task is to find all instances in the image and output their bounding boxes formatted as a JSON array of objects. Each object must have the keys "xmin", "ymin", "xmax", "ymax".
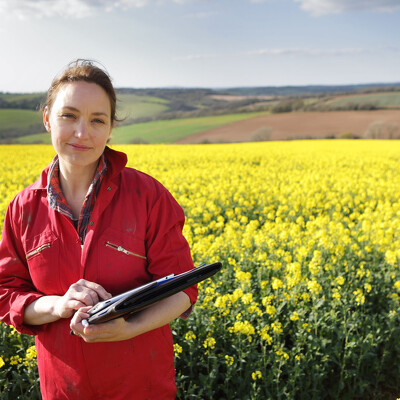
[{"xmin": 112, "ymin": 113, "xmax": 266, "ymax": 144}]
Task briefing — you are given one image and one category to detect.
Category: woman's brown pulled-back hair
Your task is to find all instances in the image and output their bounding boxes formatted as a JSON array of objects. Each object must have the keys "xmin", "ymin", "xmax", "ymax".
[{"xmin": 44, "ymin": 59, "xmax": 118, "ymax": 124}]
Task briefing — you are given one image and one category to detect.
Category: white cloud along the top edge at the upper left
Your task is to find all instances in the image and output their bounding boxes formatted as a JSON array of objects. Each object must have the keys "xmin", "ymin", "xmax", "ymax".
[{"xmin": 0, "ymin": 0, "xmax": 198, "ymax": 19}]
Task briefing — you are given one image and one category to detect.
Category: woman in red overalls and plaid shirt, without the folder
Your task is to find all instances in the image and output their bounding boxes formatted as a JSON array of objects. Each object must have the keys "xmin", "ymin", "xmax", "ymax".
[{"xmin": 0, "ymin": 60, "xmax": 197, "ymax": 400}]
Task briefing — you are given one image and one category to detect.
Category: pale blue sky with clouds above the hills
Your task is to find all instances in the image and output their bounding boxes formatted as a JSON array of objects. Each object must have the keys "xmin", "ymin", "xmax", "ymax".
[{"xmin": 0, "ymin": 0, "xmax": 400, "ymax": 92}]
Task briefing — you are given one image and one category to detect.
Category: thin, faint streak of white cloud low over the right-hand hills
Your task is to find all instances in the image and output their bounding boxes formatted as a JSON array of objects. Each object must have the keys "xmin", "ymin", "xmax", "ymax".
[{"xmin": 247, "ymin": 48, "xmax": 369, "ymax": 57}]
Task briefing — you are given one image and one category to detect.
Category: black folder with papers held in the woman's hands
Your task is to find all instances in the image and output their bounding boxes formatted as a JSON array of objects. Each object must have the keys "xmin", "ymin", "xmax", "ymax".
[{"xmin": 87, "ymin": 262, "xmax": 222, "ymax": 324}]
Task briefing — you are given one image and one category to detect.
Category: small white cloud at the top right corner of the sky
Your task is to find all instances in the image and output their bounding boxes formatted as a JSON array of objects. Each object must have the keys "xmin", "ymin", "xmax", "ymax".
[{"xmin": 294, "ymin": 0, "xmax": 400, "ymax": 16}]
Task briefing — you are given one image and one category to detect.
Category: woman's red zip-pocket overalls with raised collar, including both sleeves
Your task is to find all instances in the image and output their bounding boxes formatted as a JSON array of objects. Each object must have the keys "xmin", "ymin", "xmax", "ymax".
[{"xmin": 0, "ymin": 148, "xmax": 197, "ymax": 400}]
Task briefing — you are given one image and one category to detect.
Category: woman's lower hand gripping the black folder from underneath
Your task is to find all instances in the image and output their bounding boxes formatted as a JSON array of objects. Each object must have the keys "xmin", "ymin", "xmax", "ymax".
[{"xmin": 70, "ymin": 307, "xmax": 132, "ymax": 343}]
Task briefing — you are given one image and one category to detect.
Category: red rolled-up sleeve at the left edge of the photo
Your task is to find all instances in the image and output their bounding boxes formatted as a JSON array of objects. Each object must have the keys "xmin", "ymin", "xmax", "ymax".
[{"xmin": 0, "ymin": 199, "xmax": 43, "ymax": 335}]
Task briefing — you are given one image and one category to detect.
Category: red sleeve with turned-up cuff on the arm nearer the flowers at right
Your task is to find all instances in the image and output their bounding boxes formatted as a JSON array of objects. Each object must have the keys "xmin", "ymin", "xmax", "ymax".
[{"xmin": 146, "ymin": 190, "xmax": 198, "ymax": 319}]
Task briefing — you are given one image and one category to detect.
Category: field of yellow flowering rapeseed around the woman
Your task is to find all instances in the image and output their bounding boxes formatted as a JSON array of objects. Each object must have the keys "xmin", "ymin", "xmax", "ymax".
[{"xmin": 0, "ymin": 140, "xmax": 400, "ymax": 400}]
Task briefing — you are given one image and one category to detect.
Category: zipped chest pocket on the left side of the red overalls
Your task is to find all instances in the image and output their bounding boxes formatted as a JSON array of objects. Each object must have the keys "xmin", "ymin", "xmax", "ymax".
[{"xmin": 25, "ymin": 231, "xmax": 63, "ymax": 295}]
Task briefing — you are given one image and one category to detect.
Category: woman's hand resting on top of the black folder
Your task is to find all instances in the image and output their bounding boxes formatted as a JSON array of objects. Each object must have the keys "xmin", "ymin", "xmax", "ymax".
[{"xmin": 54, "ymin": 279, "xmax": 111, "ymax": 318}]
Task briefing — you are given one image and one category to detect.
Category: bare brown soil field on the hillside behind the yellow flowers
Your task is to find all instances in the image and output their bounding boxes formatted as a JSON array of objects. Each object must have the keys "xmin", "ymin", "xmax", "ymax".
[{"xmin": 176, "ymin": 110, "xmax": 400, "ymax": 143}]
